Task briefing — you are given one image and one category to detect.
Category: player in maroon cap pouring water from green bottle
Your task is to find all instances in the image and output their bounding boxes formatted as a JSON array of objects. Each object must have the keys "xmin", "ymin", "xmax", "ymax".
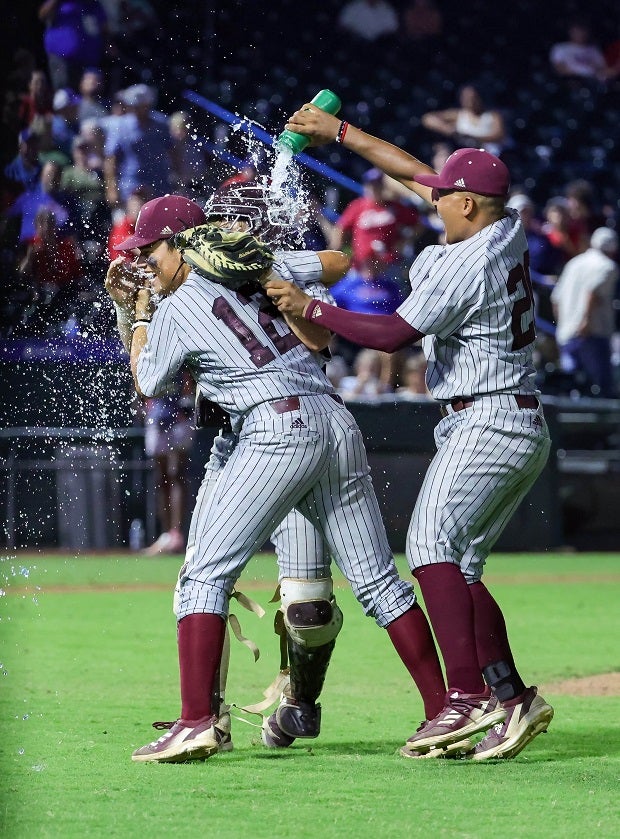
[{"xmin": 266, "ymin": 104, "xmax": 553, "ymax": 760}]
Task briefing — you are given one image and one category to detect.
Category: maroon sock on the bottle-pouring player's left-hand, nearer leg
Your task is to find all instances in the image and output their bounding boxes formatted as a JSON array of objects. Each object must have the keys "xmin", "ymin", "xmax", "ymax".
[{"xmin": 414, "ymin": 562, "xmax": 485, "ymax": 693}]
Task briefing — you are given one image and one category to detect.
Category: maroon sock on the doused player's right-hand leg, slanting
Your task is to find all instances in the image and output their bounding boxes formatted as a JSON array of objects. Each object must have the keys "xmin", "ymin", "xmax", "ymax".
[{"xmin": 387, "ymin": 603, "xmax": 446, "ymax": 720}]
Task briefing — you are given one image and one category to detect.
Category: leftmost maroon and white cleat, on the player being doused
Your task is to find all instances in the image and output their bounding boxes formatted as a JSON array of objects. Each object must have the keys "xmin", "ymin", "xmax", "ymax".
[{"xmin": 131, "ymin": 714, "xmax": 233, "ymax": 763}]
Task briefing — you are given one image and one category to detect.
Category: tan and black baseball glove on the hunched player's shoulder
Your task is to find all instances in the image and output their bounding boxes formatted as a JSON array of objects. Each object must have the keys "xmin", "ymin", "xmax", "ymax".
[{"xmin": 172, "ymin": 224, "xmax": 274, "ymax": 291}]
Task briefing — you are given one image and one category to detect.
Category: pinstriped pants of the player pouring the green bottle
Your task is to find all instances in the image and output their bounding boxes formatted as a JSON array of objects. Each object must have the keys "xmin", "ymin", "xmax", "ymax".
[{"xmin": 407, "ymin": 394, "xmax": 551, "ymax": 583}]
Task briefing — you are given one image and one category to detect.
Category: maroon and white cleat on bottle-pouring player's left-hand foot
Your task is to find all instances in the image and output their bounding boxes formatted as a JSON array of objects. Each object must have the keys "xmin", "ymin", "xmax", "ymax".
[{"xmin": 403, "ymin": 688, "xmax": 506, "ymax": 752}]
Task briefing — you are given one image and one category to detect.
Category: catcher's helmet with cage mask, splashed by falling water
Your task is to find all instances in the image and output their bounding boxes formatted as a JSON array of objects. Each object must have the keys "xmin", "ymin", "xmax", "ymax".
[{"xmin": 205, "ymin": 181, "xmax": 302, "ymax": 249}]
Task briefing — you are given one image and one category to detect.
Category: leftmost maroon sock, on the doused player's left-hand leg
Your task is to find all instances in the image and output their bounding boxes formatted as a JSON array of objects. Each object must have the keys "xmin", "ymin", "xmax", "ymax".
[{"xmin": 177, "ymin": 614, "xmax": 226, "ymax": 722}]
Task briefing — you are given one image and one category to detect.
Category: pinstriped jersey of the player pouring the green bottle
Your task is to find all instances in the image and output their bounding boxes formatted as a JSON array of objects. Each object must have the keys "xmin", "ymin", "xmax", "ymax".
[{"xmin": 397, "ymin": 210, "xmax": 536, "ymax": 401}]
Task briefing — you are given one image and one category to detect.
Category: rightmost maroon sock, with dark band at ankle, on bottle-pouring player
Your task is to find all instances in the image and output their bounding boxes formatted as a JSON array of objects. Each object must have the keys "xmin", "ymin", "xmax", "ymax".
[{"xmin": 469, "ymin": 582, "xmax": 525, "ymax": 701}]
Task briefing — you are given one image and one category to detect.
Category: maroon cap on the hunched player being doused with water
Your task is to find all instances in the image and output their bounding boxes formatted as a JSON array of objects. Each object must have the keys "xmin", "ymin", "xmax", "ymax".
[{"xmin": 114, "ymin": 195, "xmax": 207, "ymax": 251}]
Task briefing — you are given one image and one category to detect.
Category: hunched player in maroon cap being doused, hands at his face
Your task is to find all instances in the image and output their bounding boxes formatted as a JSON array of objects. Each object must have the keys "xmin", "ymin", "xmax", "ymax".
[{"xmin": 106, "ymin": 195, "xmax": 443, "ymax": 762}]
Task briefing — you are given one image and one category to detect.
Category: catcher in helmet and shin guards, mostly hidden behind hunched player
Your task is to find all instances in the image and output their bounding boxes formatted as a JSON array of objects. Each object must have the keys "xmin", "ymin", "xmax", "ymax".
[{"xmin": 194, "ymin": 181, "xmax": 350, "ymax": 748}]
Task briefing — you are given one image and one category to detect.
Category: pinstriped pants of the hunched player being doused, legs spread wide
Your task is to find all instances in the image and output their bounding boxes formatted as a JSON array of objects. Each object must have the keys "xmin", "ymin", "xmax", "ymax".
[{"xmin": 177, "ymin": 395, "xmax": 415, "ymax": 627}]
